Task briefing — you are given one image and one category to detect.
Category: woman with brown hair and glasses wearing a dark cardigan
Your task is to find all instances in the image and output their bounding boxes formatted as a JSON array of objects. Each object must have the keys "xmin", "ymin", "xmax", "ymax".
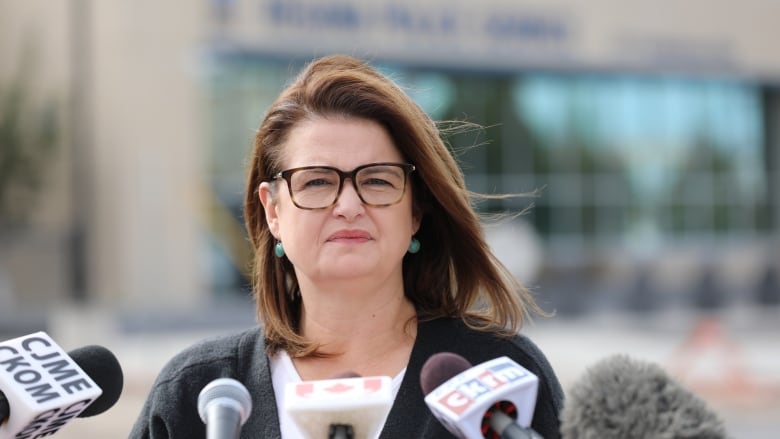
[{"xmin": 131, "ymin": 55, "xmax": 562, "ymax": 438}]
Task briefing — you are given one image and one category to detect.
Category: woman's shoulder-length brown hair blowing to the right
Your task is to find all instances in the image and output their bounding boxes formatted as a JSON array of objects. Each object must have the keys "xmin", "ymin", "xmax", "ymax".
[{"xmin": 244, "ymin": 55, "xmax": 541, "ymax": 357}]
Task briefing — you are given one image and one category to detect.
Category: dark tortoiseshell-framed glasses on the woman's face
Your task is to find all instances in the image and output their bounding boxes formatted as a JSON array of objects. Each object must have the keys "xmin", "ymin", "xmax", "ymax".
[{"xmin": 271, "ymin": 163, "xmax": 415, "ymax": 210}]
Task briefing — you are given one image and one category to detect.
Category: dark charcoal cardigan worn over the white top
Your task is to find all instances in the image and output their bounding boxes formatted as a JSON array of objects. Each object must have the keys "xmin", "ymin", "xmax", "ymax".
[{"xmin": 129, "ymin": 319, "xmax": 563, "ymax": 439}]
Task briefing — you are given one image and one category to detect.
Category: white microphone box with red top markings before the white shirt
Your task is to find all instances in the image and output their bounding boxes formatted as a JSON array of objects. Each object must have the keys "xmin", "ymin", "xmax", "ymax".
[{"xmin": 284, "ymin": 372, "xmax": 393, "ymax": 439}]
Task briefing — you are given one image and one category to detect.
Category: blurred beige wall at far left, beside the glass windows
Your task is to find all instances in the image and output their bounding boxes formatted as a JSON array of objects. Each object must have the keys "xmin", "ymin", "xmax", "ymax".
[{"xmin": 0, "ymin": 0, "xmax": 208, "ymax": 307}]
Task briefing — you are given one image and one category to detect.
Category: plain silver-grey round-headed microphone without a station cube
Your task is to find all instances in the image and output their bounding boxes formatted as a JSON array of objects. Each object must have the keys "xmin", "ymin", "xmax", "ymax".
[{"xmin": 198, "ymin": 378, "xmax": 252, "ymax": 439}]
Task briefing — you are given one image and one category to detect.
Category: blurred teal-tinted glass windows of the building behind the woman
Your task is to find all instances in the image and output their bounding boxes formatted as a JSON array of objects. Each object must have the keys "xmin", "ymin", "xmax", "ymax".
[{"xmin": 203, "ymin": 56, "xmax": 777, "ymax": 298}]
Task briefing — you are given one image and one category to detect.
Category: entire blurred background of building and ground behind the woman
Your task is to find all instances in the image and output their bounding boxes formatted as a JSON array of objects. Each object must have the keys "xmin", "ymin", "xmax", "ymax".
[{"xmin": 0, "ymin": 0, "xmax": 780, "ymax": 438}]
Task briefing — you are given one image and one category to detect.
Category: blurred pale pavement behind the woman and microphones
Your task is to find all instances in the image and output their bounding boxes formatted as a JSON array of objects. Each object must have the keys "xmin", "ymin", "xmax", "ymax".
[{"xmin": 7, "ymin": 307, "xmax": 780, "ymax": 439}]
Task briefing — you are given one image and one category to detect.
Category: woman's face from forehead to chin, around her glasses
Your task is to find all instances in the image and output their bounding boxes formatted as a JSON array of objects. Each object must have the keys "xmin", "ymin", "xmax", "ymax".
[{"xmin": 260, "ymin": 117, "xmax": 419, "ymax": 283}]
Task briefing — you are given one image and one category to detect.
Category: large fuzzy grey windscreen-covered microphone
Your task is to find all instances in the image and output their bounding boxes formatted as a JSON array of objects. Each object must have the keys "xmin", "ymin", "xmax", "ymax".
[{"xmin": 561, "ymin": 354, "xmax": 727, "ymax": 439}]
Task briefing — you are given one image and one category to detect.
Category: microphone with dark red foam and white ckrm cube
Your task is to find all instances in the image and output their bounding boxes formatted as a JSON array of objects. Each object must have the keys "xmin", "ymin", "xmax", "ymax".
[{"xmin": 420, "ymin": 352, "xmax": 541, "ymax": 439}]
